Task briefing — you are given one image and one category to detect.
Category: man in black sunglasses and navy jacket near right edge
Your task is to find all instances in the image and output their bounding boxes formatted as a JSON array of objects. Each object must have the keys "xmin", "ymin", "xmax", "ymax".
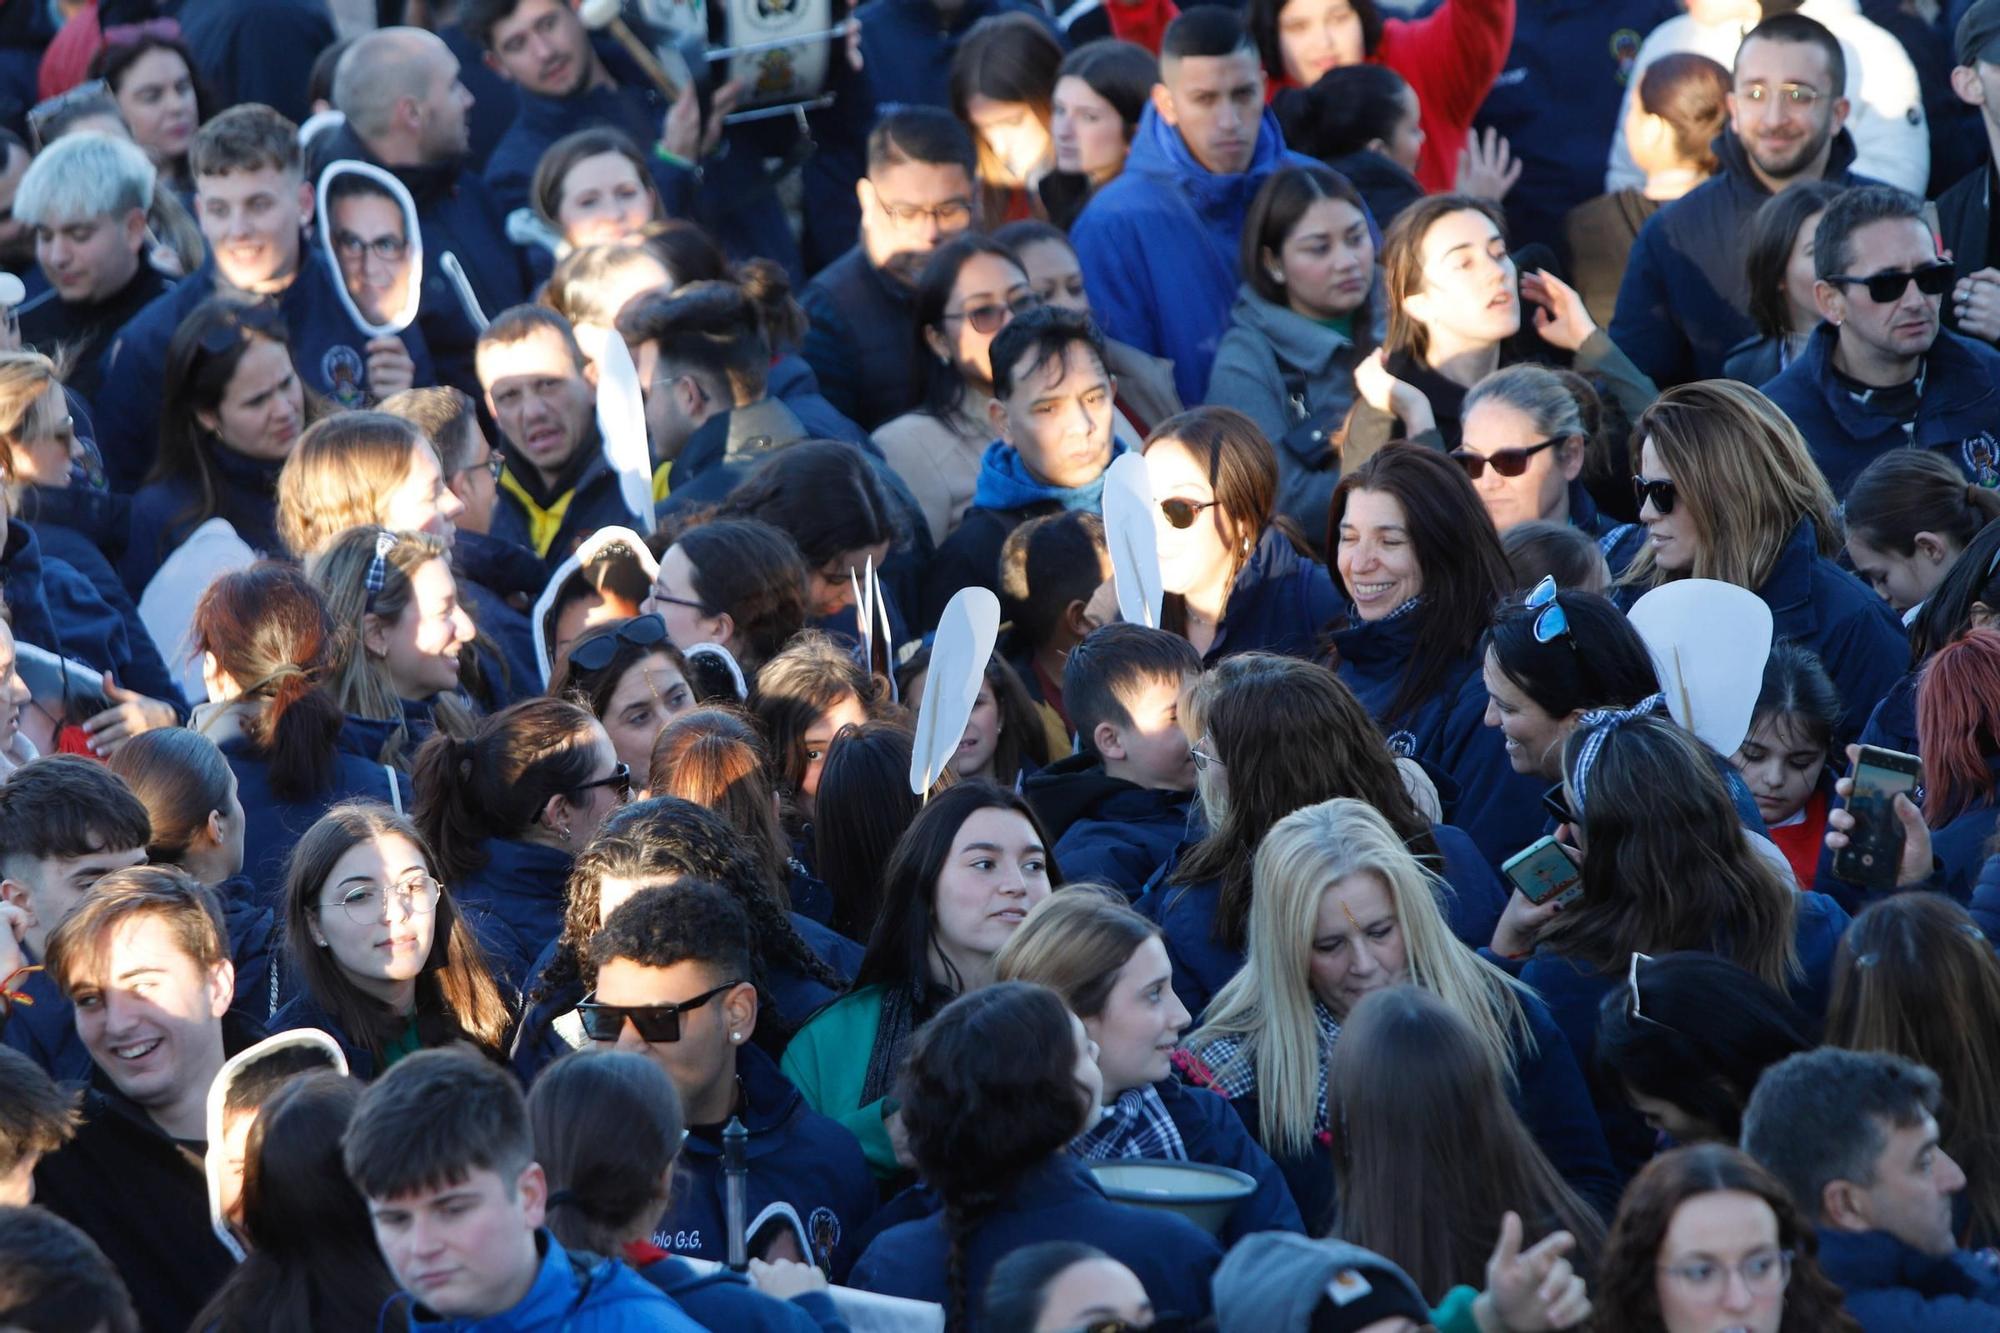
[{"xmin": 1764, "ymin": 186, "xmax": 2000, "ymax": 496}]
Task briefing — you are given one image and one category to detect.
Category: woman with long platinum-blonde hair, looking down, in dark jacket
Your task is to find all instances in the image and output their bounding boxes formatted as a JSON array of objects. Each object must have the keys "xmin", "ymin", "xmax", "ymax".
[{"xmin": 1182, "ymin": 799, "xmax": 1618, "ymax": 1235}]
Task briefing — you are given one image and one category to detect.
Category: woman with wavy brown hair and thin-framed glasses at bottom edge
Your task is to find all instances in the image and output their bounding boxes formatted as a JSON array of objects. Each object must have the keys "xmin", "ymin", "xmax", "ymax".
[{"xmin": 1590, "ymin": 1143, "xmax": 1860, "ymax": 1333}]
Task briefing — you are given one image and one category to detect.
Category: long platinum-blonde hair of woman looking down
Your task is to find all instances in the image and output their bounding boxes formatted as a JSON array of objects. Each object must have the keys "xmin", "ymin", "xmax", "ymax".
[{"xmin": 1188, "ymin": 797, "xmax": 1536, "ymax": 1153}]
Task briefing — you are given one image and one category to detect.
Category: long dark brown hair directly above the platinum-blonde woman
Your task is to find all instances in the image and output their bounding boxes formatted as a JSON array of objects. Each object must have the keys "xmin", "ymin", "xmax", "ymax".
[{"xmin": 1172, "ymin": 652, "xmax": 1442, "ymax": 951}]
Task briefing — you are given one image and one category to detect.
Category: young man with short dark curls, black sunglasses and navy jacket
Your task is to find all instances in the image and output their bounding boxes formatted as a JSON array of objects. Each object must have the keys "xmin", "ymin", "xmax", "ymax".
[{"xmin": 576, "ymin": 881, "xmax": 876, "ymax": 1279}]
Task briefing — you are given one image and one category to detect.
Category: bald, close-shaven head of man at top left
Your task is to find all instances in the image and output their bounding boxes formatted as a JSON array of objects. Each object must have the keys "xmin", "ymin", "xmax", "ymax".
[{"xmin": 334, "ymin": 28, "xmax": 472, "ymax": 166}]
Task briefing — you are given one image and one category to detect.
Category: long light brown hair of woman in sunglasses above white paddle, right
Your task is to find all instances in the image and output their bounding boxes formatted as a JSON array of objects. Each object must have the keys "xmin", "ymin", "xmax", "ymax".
[{"xmin": 1618, "ymin": 380, "xmax": 1844, "ymax": 592}]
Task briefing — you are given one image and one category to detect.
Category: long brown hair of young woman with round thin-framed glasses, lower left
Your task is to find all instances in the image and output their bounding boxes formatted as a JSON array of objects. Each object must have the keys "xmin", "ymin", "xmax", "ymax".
[{"xmin": 282, "ymin": 801, "xmax": 514, "ymax": 1061}]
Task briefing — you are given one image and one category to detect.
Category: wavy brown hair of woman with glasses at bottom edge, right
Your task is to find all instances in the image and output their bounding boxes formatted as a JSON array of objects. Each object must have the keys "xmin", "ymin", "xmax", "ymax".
[{"xmin": 1590, "ymin": 1143, "xmax": 1860, "ymax": 1333}]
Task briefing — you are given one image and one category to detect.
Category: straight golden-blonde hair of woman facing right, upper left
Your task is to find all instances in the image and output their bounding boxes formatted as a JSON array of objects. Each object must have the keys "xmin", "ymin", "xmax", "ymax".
[{"xmin": 278, "ymin": 412, "xmax": 444, "ymax": 560}]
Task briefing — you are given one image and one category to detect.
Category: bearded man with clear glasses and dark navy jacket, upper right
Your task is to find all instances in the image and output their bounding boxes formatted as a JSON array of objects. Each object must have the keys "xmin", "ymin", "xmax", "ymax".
[{"xmin": 1610, "ymin": 14, "xmax": 1876, "ymax": 388}]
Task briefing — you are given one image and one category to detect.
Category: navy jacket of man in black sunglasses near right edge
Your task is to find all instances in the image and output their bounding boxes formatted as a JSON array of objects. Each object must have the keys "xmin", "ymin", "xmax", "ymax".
[{"xmin": 1764, "ymin": 324, "xmax": 2000, "ymax": 496}]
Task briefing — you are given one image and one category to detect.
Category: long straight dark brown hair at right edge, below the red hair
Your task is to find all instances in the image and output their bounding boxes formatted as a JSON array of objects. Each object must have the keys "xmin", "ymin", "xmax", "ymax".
[{"xmin": 1826, "ymin": 893, "xmax": 2000, "ymax": 1247}]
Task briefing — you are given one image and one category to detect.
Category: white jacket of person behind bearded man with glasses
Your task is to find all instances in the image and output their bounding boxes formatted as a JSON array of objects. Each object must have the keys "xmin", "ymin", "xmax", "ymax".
[{"xmin": 1604, "ymin": 0, "xmax": 1930, "ymax": 198}]
